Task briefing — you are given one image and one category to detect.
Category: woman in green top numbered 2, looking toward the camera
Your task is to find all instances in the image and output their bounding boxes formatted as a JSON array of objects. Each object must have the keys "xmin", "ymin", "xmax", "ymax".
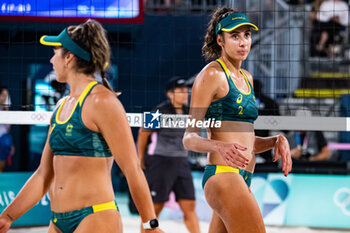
[{"xmin": 183, "ymin": 8, "xmax": 292, "ymax": 233}]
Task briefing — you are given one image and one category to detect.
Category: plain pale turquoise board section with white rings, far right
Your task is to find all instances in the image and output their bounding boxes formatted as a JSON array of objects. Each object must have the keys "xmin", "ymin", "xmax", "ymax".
[{"xmin": 285, "ymin": 175, "xmax": 350, "ymax": 228}]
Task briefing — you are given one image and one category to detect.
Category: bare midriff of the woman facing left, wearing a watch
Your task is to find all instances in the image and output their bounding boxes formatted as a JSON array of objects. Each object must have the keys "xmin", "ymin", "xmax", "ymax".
[{"xmin": 50, "ymin": 155, "xmax": 114, "ymax": 213}]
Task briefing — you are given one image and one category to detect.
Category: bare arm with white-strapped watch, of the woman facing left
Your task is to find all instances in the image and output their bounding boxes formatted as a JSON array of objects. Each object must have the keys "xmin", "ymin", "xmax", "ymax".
[{"xmin": 88, "ymin": 91, "xmax": 162, "ymax": 232}]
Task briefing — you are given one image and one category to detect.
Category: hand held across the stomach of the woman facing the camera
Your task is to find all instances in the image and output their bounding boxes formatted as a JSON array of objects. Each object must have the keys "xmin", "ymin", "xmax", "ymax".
[{"xmin": 216, "ymin": 141, "xmax": 249, "ymax": 168}]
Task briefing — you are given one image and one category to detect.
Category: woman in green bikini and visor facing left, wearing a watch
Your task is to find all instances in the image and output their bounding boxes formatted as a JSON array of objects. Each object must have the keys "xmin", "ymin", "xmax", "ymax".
[{"xmin": 0, "ymin": 20, "xmax": 162, "ymax": 233}]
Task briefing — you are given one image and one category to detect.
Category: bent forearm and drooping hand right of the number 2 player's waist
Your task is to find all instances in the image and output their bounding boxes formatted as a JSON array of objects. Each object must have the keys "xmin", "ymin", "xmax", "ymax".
[{"xmin": 254, "ymin": 135, "xmax": 292, "ymax": 176}]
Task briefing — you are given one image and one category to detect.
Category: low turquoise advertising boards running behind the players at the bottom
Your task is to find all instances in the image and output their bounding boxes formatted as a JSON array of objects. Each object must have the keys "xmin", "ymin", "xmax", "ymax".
[{"xmin": 0, "ymin": 172, "xmax": 350, "ymax": 228}]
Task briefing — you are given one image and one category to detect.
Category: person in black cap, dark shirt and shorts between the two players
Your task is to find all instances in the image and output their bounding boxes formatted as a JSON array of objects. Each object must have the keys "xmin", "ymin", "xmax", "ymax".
[{"xmin": 137, "ymin": 77, "xmax": 200, "ymax": 233}]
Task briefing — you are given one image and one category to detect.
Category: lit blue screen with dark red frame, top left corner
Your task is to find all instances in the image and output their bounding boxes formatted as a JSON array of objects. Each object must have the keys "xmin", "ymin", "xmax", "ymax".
[{"xmin": 0, "ymin": 0, "xmax": 144, "ymax": 24}]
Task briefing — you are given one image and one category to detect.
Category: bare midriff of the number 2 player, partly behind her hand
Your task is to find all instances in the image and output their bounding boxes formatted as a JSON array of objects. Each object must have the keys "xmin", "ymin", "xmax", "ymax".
[{"xmin": 208, "ymin": 121, "xmax": 255, "ymax": 173}]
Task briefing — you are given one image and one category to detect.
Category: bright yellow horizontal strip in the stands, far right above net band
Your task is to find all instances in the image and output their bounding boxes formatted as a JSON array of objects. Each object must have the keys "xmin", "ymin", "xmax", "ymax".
[{"xmin": 294, "ymin": 89, "xmax": 350, "ymax": 98}]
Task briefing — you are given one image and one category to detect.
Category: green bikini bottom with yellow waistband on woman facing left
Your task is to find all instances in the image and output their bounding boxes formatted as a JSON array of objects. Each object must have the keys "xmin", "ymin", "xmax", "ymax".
[{"xmin": 51, "ymin": 201, "xmax": 118, "ymax": 233}]
